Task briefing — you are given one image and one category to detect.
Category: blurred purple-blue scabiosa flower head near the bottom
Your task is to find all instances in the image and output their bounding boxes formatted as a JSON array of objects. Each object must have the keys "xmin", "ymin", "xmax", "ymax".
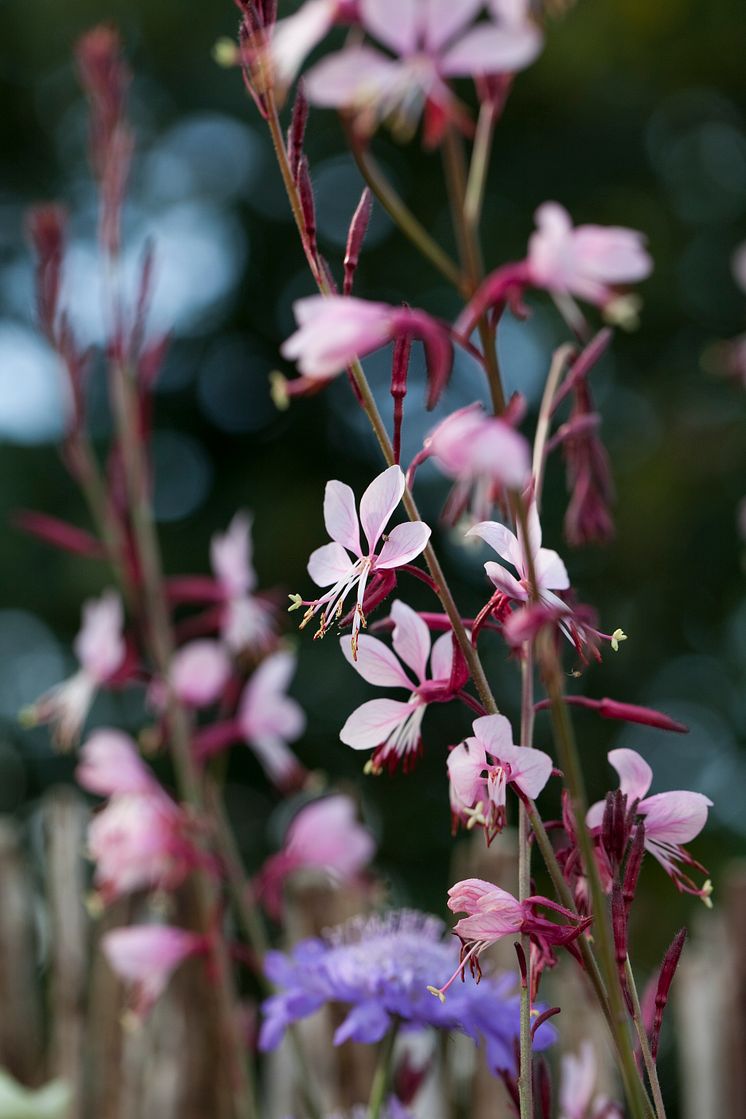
[{"xmin": 259, "ymin": 910, "xmax": 554, "ymax": 1071}]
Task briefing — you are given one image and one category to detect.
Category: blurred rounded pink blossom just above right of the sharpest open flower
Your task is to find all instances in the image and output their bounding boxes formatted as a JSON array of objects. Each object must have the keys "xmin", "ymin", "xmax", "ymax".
[{"xmin": 425, "ymin": 404, "xmax": 531, "ymax": 520}]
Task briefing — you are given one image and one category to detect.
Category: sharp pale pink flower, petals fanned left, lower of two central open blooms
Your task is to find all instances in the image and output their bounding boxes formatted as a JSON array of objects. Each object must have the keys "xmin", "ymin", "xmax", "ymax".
[{"xmin": 339, "ymin": 600, "xmax": 457, "ymax": 773}]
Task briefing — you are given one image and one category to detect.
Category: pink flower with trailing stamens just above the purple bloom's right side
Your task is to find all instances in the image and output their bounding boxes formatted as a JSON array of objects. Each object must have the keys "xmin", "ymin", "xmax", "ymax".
[{"xmin": 428, "ymin": 878, "xmax": 593, "ymax": 1000}]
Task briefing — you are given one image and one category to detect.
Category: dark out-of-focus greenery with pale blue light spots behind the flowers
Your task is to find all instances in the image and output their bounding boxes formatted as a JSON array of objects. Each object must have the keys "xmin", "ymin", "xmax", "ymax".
[{"xmin": 0, "ymin": 0, "xmax": 746, "ymax": 1110}]
